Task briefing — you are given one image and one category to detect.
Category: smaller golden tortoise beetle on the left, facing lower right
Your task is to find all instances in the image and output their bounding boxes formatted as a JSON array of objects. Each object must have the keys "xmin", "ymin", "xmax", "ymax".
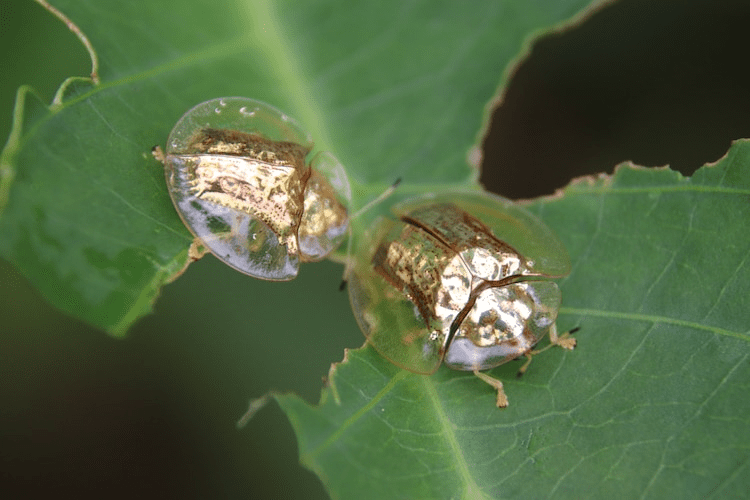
[{"xmin": 154, "ymin": 97, "xmax": 351, "ymax": 281}]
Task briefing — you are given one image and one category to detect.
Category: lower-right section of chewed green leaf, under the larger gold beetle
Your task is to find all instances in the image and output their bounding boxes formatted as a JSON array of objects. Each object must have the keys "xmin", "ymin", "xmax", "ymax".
[{"xmin": 276, "ymin": 140, "xmax": 750, "ymax": 499}]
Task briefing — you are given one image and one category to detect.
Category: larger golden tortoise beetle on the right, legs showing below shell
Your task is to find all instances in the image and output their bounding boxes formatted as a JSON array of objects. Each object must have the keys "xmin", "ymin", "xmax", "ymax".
[{"xmin": 348, "ymin": 193, "xmax": 575, "ymax": 407}]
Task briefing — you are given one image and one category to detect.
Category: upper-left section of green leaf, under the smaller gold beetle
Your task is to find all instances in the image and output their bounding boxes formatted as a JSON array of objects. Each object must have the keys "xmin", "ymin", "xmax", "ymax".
[{"xmin": 0, "ymin": 0, "xmax": 598, "ymax": 335}]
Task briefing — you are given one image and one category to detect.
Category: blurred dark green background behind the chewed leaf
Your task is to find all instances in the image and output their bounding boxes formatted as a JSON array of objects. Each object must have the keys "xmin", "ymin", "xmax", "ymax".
[{"xmin": 0, "ymin": 0, "xmax": 750, "ymax": 499}]
